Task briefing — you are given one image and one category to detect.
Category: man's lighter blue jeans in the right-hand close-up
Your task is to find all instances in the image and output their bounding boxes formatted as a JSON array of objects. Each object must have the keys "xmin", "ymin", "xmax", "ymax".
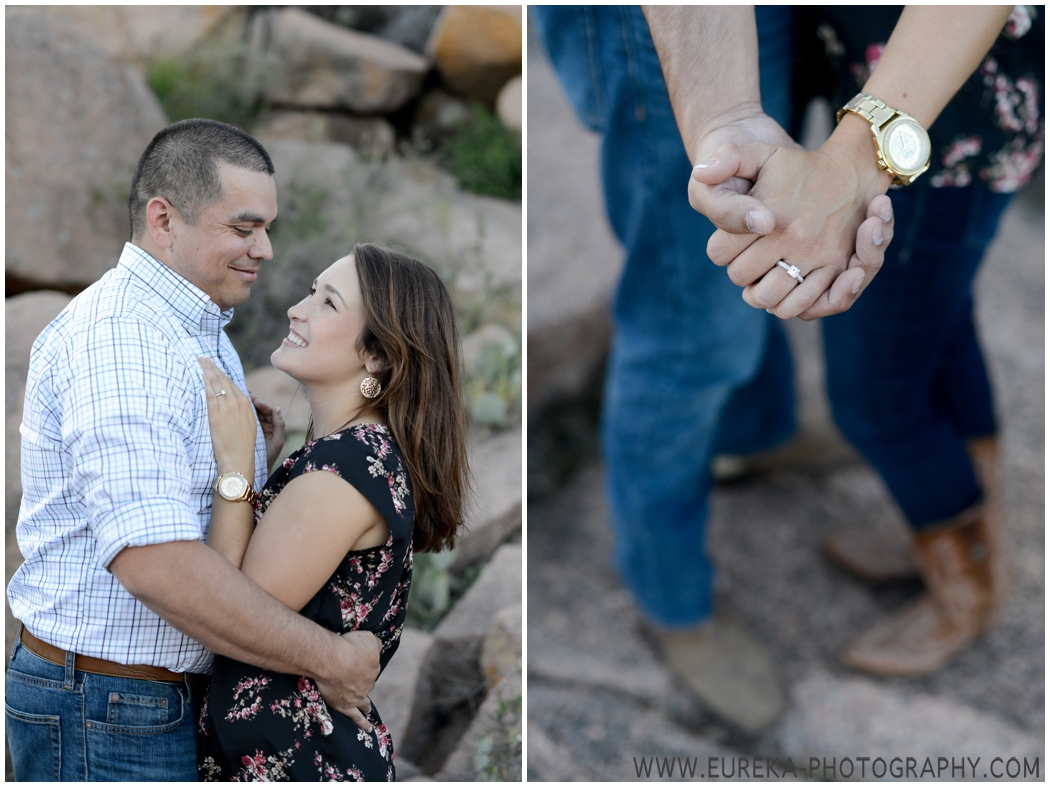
[{"xmin": 530, "ymin": 6, "xmax": 795, "ymax": 626}]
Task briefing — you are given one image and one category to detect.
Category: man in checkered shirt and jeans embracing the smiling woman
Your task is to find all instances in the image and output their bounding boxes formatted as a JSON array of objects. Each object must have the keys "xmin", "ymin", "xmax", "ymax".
[{"xmin": 6, "ymin": 120, "xmax": 379, "ymax": 782}]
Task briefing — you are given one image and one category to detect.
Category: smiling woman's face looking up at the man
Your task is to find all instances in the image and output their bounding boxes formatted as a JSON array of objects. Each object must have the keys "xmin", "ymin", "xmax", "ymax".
[{"xmin": 270, "ymin": 255, "xmax": 365, "ymax": 384}]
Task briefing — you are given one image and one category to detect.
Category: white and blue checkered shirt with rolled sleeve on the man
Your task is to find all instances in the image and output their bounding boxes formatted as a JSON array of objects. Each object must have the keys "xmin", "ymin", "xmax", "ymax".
[{"xmin": 7, "ymin": 243, "xmax": 267, "ymax": 673}]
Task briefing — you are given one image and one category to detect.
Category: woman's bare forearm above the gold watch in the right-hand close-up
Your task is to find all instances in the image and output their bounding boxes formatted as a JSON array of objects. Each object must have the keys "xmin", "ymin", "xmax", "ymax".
[{"xmin": 864, "ymin": 5, "xmax": 1013, "ymax": 128}]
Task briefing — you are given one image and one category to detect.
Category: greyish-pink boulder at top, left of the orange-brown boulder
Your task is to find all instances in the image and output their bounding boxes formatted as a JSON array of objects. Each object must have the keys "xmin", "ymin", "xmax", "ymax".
[{"xmin": 251, "ymin": 7, "xmax": 429, "ymax": 114}]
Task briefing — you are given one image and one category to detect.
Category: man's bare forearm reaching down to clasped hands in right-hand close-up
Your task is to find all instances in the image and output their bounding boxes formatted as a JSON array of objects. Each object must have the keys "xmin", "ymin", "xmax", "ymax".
[{"xmin": 643, "ymin": 5, "xmax": 762, "ymax": 155}]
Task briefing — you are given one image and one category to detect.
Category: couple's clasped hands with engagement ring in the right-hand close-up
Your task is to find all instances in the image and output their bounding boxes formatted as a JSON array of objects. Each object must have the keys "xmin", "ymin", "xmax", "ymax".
[{"xmin": 689, "ymin": 107, "xmax": 894, "ymax": 320}]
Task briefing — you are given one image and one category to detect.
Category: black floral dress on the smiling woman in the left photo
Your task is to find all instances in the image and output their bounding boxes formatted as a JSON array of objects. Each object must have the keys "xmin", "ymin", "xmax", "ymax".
[{"xmin": 197, "ymin": 424, "xmax": 414, "ymax": 782}]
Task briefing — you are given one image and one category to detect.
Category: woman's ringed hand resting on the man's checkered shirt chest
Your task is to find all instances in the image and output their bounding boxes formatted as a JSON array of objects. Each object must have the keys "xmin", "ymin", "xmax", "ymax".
[{"xmin": 197, "ymin": 357, "xmax": 258, "ymax": 483}]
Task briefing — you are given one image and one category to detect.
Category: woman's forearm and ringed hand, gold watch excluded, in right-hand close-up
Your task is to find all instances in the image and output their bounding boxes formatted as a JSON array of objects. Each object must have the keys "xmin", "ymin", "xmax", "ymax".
[{"xmin": 694, "ymin": 6, "xmax": 1012, "ymax": 318}]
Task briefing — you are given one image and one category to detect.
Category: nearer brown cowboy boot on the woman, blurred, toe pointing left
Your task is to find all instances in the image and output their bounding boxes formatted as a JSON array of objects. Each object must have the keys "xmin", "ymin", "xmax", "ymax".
[{"xmin": 843, "ymin": 505, "xmax": 1002, "ymax": 676}]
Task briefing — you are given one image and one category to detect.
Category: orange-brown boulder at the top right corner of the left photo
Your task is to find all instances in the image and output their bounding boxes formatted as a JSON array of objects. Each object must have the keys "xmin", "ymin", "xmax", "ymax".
[{"xmin": 426, "ymin": 5, "xmax": 522, "ymax": 108}]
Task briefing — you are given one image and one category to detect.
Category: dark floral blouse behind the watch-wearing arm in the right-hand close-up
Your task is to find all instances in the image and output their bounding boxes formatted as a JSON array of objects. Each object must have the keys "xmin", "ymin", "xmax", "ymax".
[{"xmin": 795, "ymin": 5, "xmax": 1046, "ymax": 193}]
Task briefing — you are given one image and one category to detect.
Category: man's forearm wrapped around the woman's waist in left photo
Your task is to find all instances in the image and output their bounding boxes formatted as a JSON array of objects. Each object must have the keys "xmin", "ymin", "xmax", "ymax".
[{"xmin": 109, "ymin": 541, "xmax": 363, "ymax": 680}]
